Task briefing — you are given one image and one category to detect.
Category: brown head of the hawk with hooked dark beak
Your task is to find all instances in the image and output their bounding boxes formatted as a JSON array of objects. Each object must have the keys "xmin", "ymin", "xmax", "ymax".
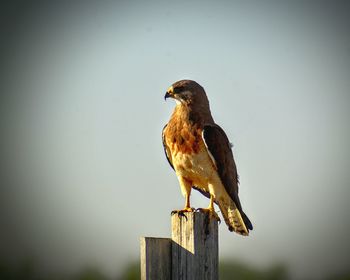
[{"xmin": 164, "ymin": 80, "xmax": 209, "ymax": 106}]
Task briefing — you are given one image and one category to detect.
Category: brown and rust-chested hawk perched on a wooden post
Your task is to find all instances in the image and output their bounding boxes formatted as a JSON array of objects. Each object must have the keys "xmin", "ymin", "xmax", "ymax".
[{"xmin": 162, "ymin": 80, "xmax": 253, "ymax": 235}]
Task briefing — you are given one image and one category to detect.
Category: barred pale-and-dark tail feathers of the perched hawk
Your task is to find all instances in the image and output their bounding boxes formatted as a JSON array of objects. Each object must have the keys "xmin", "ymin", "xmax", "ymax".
[{"xmin": 218, "ymin": 200, "xmax": 253, "ymax": 236}]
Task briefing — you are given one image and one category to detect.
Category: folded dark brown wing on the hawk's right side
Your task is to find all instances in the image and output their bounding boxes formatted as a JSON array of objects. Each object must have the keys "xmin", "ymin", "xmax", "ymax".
[{"xmin": 202, "ymin": 124, "xmax": 242, "ymax": 211}]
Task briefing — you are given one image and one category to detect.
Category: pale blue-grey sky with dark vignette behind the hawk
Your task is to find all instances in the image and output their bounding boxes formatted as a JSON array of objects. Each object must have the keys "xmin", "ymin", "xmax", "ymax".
[{"xmin": 0, "ymin": 1, "xmax": 350, "ymax": 279}]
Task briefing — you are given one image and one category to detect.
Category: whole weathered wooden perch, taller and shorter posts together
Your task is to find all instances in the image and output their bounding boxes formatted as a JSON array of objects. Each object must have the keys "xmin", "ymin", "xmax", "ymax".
[{"xmin": 141, "ymin": 212, "xmax": 219, "ymax": 280}]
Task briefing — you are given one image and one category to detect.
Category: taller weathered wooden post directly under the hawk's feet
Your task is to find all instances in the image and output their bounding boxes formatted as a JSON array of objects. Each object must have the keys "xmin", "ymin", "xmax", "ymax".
[{"xmin": 171, "ymin": 212, "xmax": 219, "ymax": 280}]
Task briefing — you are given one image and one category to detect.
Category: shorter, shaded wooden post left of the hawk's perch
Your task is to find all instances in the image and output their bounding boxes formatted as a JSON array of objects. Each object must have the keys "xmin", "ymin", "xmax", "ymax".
[{"xmin": 140, "ymin": 237, "xmax": 171, "ymax": 280}]
